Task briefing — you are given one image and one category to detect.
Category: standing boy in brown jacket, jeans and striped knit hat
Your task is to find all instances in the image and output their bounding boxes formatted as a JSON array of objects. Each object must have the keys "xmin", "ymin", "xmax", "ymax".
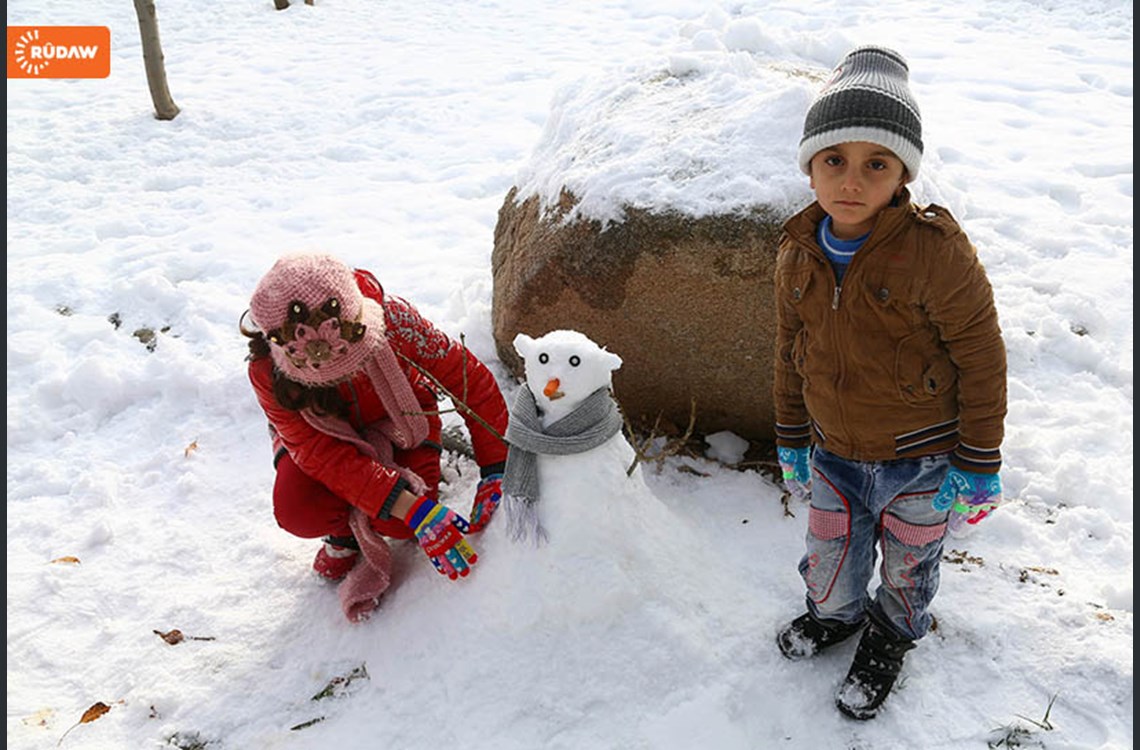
[{"xmin": 774, "ymin": 47, "xmax": 1005, "ymax": 719}]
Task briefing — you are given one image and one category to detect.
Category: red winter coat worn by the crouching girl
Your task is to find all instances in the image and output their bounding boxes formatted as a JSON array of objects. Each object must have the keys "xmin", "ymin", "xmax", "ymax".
[{"xmin": 250, "ymin": 265, "xmax": 507, "ymax": 519}]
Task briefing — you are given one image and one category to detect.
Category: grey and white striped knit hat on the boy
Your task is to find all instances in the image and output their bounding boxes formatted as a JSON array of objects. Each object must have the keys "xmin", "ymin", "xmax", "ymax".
[{"xmin": 799, "ymin": 47, "xmax": 922, "ymax": 181}]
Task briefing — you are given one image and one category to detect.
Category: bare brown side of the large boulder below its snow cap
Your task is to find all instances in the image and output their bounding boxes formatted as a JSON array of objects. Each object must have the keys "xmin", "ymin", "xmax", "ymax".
[{"xmin": 491, "ymin": 189, "xmax": 782, "ymax": 442}]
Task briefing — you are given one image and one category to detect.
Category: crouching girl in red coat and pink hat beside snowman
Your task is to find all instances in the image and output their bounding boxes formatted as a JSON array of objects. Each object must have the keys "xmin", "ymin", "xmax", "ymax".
[{"xmin": 242, "ymin": 253, "xmax": 507, "ymax": 619}]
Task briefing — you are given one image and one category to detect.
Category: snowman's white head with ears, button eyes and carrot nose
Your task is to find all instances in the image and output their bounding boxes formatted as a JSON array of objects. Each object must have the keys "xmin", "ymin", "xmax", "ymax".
[{"xmin": 514, "ymin": 329, "xmax": 621, "ymax": 424}]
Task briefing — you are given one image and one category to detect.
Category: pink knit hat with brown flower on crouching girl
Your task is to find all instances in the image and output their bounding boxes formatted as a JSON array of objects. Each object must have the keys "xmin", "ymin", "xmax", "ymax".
[{"xmin": 250, "ymin": 253, "xmax": 384, "ymax": 385}]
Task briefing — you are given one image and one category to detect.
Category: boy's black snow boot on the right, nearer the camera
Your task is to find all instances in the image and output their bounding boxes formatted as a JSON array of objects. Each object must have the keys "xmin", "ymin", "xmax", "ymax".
[{"xmin": 836, "ymin": 622, "xmax": 914, "ymax": 722}]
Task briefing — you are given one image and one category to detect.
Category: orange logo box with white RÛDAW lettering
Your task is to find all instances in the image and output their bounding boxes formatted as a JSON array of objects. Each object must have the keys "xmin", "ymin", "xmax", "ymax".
[{"xmin": 8, "ymin": 26, "xmax": 111, "ymax": 79}]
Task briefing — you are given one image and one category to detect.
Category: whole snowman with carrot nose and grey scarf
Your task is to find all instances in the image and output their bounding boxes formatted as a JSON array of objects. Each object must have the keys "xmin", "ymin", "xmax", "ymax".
[{"xmin": 490, "ymin": 329, "xmax": 692, "ymax": 619}]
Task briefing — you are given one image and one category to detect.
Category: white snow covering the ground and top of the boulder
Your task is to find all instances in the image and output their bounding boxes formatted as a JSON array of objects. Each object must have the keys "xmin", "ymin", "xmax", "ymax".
[{"xmin": 7, "ymin": 0, "xmax": 1134, "ymax": 750}]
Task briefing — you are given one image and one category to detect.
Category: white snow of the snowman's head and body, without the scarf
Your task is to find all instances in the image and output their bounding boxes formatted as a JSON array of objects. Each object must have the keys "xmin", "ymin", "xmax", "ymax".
[{"xmin": 492, "ymin": 331, "xmax": 684, "ymax": 618}]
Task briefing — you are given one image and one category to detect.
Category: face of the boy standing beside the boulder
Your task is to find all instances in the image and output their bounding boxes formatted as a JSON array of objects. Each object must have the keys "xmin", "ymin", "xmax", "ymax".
[{"xmin": 811, "ymin": 141, "xmax": 906, "ymax": 239}]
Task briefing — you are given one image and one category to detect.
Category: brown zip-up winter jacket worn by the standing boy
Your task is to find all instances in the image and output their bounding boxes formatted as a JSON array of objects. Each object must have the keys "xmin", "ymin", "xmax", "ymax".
[{"xmin": 773, "ymin": 191, "xmax": 1005, "ymax": 473}]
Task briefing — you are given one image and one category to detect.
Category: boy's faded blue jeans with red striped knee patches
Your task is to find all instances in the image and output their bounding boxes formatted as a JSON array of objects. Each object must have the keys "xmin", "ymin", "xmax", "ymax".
[{"xmin": 799, "ymin": 447, "xmax": 950, "ymax": 639}]
